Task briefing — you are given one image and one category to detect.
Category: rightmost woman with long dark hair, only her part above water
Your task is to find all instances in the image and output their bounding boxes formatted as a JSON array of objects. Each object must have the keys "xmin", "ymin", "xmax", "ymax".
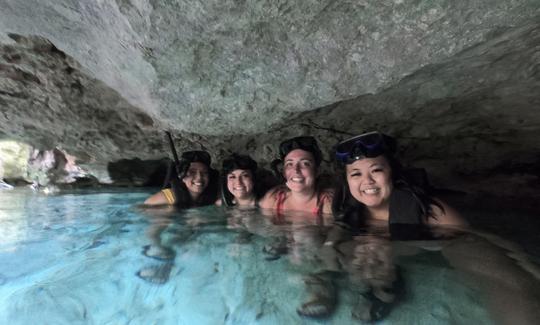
[{"xmin": 332, "ymin": 132, "xmax": 467, "ymax": 229}]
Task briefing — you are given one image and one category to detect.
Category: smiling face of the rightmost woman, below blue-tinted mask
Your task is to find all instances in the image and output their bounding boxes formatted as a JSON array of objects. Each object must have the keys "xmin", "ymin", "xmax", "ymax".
[{"xmin": 346, "ymin": 156, "xmax": 393, "ymax": 209}]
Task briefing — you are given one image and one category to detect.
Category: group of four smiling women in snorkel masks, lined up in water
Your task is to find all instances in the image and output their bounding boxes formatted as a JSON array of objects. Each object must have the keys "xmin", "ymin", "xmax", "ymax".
[{"xmin": 145, "ymin": 132, "xmax": 472, "ymax": 320}]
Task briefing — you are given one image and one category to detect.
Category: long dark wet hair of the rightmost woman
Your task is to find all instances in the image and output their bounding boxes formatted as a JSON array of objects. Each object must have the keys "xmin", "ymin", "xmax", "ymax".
[{"xmin": 332, "ymin": 153, "xmax": 444, "ymax": 228}]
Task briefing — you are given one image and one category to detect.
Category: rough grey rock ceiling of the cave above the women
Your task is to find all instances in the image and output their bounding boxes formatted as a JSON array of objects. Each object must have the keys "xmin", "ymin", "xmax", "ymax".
[{"xmin": 0, "ymin": 0, "xmax": 540, "ymax": 195}]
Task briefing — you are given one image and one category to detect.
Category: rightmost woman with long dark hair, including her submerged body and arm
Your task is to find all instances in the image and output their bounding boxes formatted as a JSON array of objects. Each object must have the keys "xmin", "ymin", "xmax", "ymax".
[{"xmin": 322, "ymin": 132, "xmax": 540, "ymax": 324}]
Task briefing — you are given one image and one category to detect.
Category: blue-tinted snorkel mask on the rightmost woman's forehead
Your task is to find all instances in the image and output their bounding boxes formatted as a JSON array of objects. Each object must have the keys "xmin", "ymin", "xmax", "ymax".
[{"xmin": 336, "ymin": 131, "xmax": 396, "ymax": 164}]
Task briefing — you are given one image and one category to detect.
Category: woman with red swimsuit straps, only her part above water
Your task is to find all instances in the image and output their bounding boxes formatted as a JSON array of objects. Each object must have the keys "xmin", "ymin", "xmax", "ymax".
[{"xmin": 259, "ymin": 136, "xmax": 332, "ymax": 220}]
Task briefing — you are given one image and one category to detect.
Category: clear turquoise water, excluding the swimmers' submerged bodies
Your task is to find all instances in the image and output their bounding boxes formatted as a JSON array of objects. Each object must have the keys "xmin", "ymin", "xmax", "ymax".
[{"xmin": 0, "ymin": 189, "xmax": 536, "ymax": 324}]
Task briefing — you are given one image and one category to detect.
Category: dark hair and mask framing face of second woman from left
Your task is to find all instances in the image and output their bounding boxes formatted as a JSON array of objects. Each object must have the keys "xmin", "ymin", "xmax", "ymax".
[{"xmin": 220, "ymin": 153, "xmax": 262, "ymax": 206}]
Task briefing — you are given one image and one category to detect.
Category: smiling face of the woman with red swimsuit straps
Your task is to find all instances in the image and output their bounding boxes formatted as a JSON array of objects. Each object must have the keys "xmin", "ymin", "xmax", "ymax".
[{"xmin": 283, "ymin": 149, "xmax": 317, "ymax": 192}]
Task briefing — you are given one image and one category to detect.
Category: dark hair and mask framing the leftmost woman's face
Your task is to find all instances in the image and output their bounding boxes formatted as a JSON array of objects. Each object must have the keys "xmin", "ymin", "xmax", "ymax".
[{"xmin": 168, "ymin": 151, "xmax": 219, "ymax": 209}]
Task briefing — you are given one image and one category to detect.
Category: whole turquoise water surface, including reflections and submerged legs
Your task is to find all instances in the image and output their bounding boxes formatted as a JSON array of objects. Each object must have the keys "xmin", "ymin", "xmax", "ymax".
[{"xmin": 0, "ymin": 190, "xmax": 540, "ymax": 324}]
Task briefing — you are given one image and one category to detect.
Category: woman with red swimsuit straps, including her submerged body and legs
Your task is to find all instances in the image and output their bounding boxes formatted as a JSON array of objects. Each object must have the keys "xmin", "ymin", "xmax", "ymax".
[{"xmin": 259, "ymin": 136, "xmax": 336, "ymax": 317}]
